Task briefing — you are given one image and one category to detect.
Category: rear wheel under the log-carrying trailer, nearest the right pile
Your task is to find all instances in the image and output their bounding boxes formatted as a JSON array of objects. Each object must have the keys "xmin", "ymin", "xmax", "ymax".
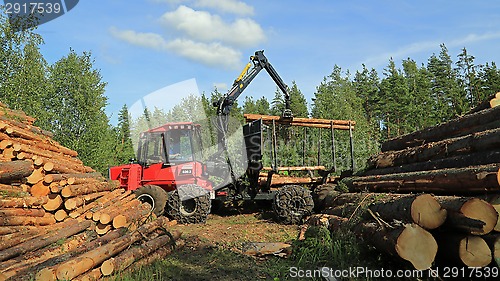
[{"xmin": 273, "ymin": 185, "xmax": 314, "ymax": 224}]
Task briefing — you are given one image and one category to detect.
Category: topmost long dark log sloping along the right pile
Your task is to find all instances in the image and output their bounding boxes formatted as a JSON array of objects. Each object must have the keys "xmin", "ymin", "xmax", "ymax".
[{"xmin": 382, "ymin": 106, "xmax": 500, "ymax": 151}]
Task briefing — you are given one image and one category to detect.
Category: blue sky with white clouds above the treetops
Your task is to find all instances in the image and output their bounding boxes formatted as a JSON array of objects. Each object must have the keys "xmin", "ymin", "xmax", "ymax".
[{"xmin": 37, "ymin": 0, "xmax": 500, "ymax": 121}]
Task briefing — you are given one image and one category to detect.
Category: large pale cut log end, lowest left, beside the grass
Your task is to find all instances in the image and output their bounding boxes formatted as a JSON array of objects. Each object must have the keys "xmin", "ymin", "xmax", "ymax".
[{"xmin": 396, "ymin": 224, "xmax": 438, "ymax": 270}]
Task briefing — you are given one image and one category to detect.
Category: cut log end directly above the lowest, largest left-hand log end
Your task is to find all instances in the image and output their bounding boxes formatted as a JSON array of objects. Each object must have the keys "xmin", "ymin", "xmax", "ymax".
[{"xmin": 411, "ymin": 194, "xmax": 447, "ymax": 229}]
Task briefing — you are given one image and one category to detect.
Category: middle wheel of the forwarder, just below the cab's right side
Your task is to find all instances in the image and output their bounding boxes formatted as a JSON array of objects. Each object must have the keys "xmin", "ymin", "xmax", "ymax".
[{"xmin": 167, "ymin": 184, "xmax": 212, "ymax": 224}]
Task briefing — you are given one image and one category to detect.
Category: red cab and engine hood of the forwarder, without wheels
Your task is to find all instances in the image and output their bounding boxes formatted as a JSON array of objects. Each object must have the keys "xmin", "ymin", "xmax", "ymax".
[{"xmin": 109, "ymin": 122, "xmax": 213, "ymax": 192}]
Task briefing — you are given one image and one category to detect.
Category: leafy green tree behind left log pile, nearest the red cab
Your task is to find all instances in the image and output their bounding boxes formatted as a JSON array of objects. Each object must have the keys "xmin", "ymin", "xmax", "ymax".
[{"xmin": 47, "ymin": 50, "xmax": 115, "ymax": 173}]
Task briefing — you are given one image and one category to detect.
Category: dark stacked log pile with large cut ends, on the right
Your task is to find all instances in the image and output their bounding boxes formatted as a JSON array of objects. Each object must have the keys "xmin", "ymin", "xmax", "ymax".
[{"xmin": 308, "ymin": 93, "xmax": 500, "ymax": 269}]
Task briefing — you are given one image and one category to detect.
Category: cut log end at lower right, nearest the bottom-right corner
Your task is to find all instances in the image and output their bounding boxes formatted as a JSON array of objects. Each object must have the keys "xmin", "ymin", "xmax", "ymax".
[{"xmin": 459, "ymin": 236, "xmax": 491, "ymax": 267}]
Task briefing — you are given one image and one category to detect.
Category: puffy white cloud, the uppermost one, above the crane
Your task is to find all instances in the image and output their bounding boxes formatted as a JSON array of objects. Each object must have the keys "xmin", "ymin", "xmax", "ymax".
[{"xmin": 160, "ymin": 5, "xmax": 265, "ymax": 47}]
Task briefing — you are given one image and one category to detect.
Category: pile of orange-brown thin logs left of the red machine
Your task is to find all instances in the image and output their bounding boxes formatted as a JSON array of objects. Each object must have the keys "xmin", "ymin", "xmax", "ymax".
[{"xmin": 0, "ymin": 104, "xmax": 178, "ymax": 281}]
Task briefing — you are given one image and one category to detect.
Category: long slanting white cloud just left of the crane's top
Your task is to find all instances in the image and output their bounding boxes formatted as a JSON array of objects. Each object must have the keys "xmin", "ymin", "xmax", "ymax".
[{"xmin": 109, "ymin": 27, "xmax": 241, "ymax": 69}]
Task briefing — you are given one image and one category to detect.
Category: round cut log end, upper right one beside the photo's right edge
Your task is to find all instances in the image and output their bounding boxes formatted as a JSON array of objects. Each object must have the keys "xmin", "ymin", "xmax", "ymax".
[{"xmin": 460, "ymin": 198, "xmax": 498, "ymax": 235}]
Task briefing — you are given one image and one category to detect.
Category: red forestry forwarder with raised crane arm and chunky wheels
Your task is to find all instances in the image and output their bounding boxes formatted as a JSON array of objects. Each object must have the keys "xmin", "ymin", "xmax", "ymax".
[{"xmin": 110, "ymin": 51, "xmax": 352, "ymax": 223}]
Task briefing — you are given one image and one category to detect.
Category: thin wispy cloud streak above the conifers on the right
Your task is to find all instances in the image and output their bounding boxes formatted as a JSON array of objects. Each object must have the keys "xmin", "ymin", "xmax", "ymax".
[{"xmin": 363, "ymin": 32, "xmax": 500, "ymax": 65}]
